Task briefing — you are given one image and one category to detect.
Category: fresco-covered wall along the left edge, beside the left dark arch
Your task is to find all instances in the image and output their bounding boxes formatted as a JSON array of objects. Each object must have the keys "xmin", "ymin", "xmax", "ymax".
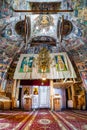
[{"xmin": 0, "ymin": 0, "xmax": 23, "ymax": 80}]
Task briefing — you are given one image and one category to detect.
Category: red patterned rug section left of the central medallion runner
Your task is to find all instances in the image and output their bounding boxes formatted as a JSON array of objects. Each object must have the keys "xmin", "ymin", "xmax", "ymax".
[{"xmin": 0, "ymin": 111, "xmax": 33, "ymax": 130}]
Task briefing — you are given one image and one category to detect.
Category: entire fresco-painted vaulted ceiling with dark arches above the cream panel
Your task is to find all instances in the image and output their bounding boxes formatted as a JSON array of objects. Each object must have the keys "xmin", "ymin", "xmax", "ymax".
[{"xmin": 0, "ymin": 0, "xmax": 87, "ymax": 82}]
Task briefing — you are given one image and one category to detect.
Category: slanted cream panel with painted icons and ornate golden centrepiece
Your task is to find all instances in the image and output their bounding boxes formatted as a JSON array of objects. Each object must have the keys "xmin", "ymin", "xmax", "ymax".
[{"xmin": 14, "ymin": 52, "xmax": 76, "ymax": 79}]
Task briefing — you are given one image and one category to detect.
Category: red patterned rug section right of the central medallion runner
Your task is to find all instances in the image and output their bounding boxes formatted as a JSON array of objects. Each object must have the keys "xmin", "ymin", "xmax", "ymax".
[{"xmin": 54, "ymin": 111, "xmax": 87, "ymax": 130}]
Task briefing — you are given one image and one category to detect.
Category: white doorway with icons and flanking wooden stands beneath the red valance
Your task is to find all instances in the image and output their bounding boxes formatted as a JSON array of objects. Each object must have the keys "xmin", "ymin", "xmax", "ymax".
[{"xmin": 16, "ymin": 85, "xmax": 66, "ymax": 111}]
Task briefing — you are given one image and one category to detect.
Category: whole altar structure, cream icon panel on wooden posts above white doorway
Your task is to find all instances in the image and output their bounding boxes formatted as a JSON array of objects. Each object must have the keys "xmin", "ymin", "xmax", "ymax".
[{"xmin": 13, "ymin": 51, "xmax": 82, "ymax": 111}]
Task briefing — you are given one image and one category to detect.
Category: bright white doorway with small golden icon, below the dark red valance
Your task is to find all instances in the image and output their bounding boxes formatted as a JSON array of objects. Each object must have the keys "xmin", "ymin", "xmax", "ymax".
[{"xmin": 32, "ymin": 86, "xmax": 50, "ymax": 109}]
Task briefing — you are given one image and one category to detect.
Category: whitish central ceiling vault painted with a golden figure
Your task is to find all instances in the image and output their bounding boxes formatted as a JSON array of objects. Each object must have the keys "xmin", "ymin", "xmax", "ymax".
[{"xmin": 32, "ymin": 14, "xmax": 55, "ymax": 36}]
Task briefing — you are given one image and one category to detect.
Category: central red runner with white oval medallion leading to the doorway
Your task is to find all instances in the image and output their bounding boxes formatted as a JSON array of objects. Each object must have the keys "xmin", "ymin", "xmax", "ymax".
[{"xmin": 28, "ymin": 110, "xmax": 67, "ymax": 130}]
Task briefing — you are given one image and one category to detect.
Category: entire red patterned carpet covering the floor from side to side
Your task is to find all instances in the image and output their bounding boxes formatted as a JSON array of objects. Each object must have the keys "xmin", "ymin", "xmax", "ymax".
[{"xmin": 0, "ymin": 109, "xmax": 87, "ymax": 130}]
